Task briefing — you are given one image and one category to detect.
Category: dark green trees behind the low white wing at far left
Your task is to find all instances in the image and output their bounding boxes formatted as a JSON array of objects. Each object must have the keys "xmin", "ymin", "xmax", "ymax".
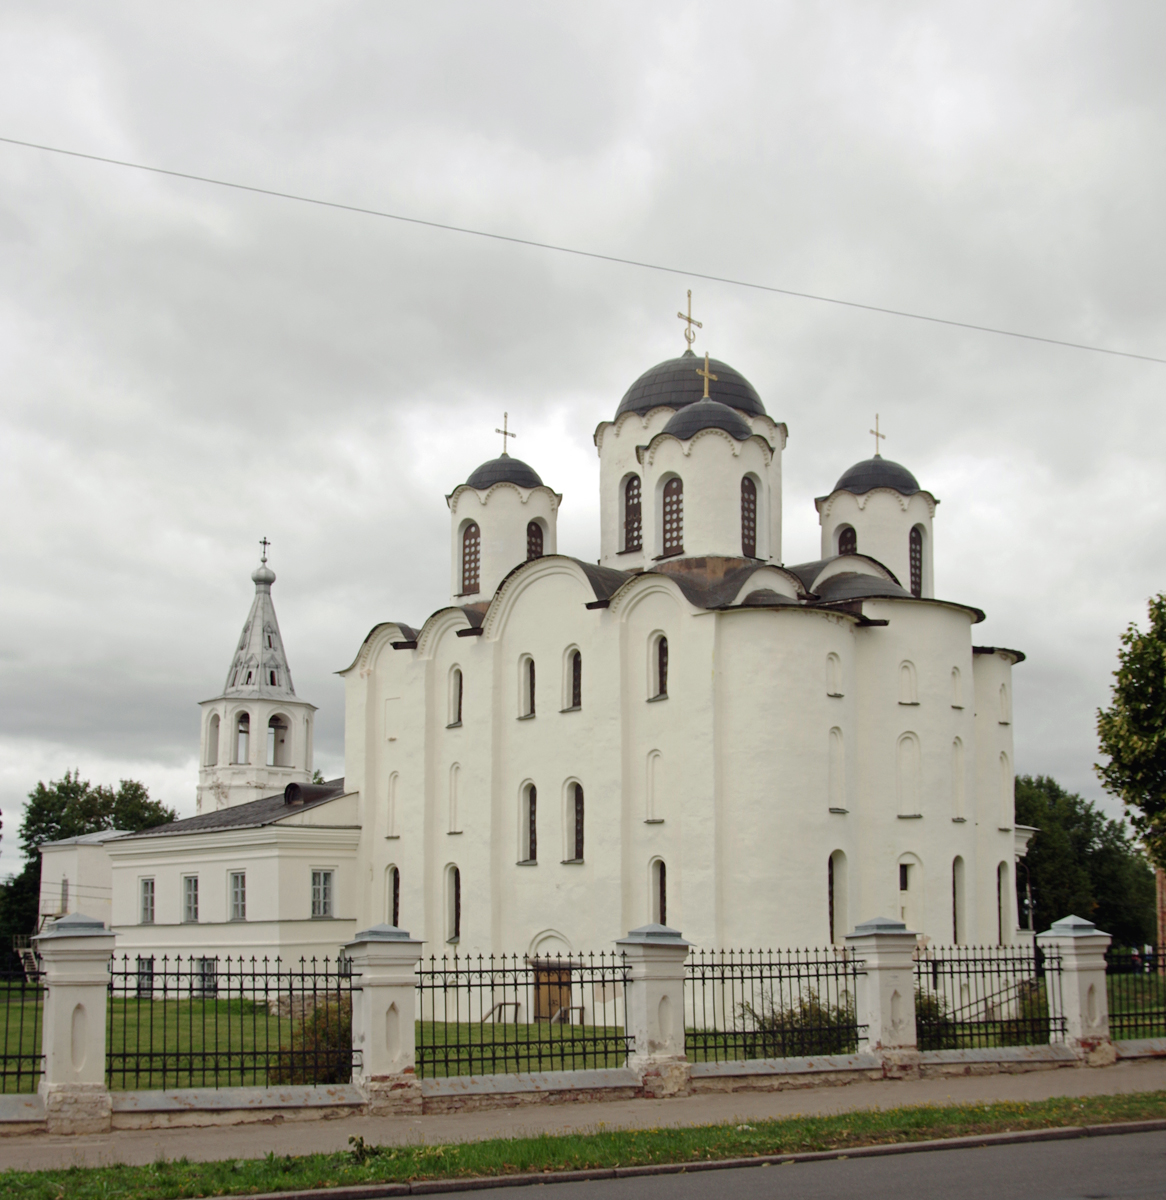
[{"xmin": 0, "ymin": 770, "xmax": 178, "ymax": 953}]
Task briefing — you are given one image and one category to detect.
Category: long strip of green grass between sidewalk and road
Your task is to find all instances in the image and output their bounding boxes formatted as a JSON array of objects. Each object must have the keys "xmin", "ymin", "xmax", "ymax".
[{"xmin": 0, "ymin": 1092, "xmax": 1166, "ymax": 1200}]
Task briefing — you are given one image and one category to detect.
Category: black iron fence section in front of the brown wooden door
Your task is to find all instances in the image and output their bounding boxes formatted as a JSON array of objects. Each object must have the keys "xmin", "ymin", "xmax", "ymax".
[{"xmin": 416, "ymin": 953, "xmax": 632, "ymax": 1079}]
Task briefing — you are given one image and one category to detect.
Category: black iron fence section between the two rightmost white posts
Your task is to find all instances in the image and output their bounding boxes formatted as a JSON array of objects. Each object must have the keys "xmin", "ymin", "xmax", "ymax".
[{"xmin": 915, "ymin": 946, "xmax": 1065, "ymax": 1050}]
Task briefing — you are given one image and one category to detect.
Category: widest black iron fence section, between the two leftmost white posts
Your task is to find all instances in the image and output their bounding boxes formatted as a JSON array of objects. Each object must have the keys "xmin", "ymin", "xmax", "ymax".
[{"xmin": 106, "ymin": 955, "xmax": 359, "ymax": 1091}]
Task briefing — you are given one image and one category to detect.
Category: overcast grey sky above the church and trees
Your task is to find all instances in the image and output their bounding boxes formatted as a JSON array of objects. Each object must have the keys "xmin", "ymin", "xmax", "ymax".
[{"xmin": 0, "ymin": 0, "xmax": 1166, "ymax": 870}]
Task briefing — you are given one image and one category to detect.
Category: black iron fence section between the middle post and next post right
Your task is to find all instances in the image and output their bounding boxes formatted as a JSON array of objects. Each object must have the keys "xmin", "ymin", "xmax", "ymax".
[{"xmin": 684, "ymin": 949, "xmax": 866, "ymax": 1062}]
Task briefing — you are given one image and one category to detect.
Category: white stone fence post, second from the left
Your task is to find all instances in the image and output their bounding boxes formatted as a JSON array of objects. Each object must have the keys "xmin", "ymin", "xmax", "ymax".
[{"xmin": 344, "ymin": 925, "xmax": 421, "ymax": 1116}]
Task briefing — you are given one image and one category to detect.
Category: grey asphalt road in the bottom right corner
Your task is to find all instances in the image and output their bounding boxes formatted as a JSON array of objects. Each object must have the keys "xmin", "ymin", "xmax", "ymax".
[{"xmin": 439, "ymin": 1133, "xmax": 1166, "ymax": 1200}]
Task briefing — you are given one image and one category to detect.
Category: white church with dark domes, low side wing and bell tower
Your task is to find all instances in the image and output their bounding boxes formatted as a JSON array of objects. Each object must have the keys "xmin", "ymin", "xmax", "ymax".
[{"xmin": 43, "ymin": 336, "xmax": 1032, "ymax": 959}]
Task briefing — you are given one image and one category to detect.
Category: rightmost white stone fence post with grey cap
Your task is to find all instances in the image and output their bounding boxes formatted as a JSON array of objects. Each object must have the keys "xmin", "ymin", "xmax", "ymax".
[{"xmin": 1036, "ymin": 917, "xmax": 1117, "ymax": 1067}]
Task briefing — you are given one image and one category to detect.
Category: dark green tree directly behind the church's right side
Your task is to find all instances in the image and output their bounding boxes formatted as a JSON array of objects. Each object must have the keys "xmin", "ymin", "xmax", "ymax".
[{"xmin": 1016, "ymin": 775, "xmax": 1155, "ymax": 946}]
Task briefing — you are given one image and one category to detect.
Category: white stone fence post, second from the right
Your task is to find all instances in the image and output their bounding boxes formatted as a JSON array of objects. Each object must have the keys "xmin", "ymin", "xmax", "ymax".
[{"xmin": 846, "ymin": 917, "xmax": 919, "ymax": 1078}]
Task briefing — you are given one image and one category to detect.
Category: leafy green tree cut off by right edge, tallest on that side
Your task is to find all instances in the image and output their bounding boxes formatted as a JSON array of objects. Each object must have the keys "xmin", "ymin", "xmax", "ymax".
[{"xmin": 1095, "ymin": 593, "xmax": 1166, "ymax": 866}]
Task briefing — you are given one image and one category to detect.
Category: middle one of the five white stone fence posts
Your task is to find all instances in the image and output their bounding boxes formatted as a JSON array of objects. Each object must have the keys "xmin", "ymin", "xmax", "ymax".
[{"xmin": 615, "ymin": 925, "xmax": 689, "ymax": 1098}]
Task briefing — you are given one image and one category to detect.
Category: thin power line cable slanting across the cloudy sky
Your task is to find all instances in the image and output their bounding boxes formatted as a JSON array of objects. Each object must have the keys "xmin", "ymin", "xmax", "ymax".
[{"xmin": 0, "ymin": 137, "xmax": 1166, "ymax": 365}]
